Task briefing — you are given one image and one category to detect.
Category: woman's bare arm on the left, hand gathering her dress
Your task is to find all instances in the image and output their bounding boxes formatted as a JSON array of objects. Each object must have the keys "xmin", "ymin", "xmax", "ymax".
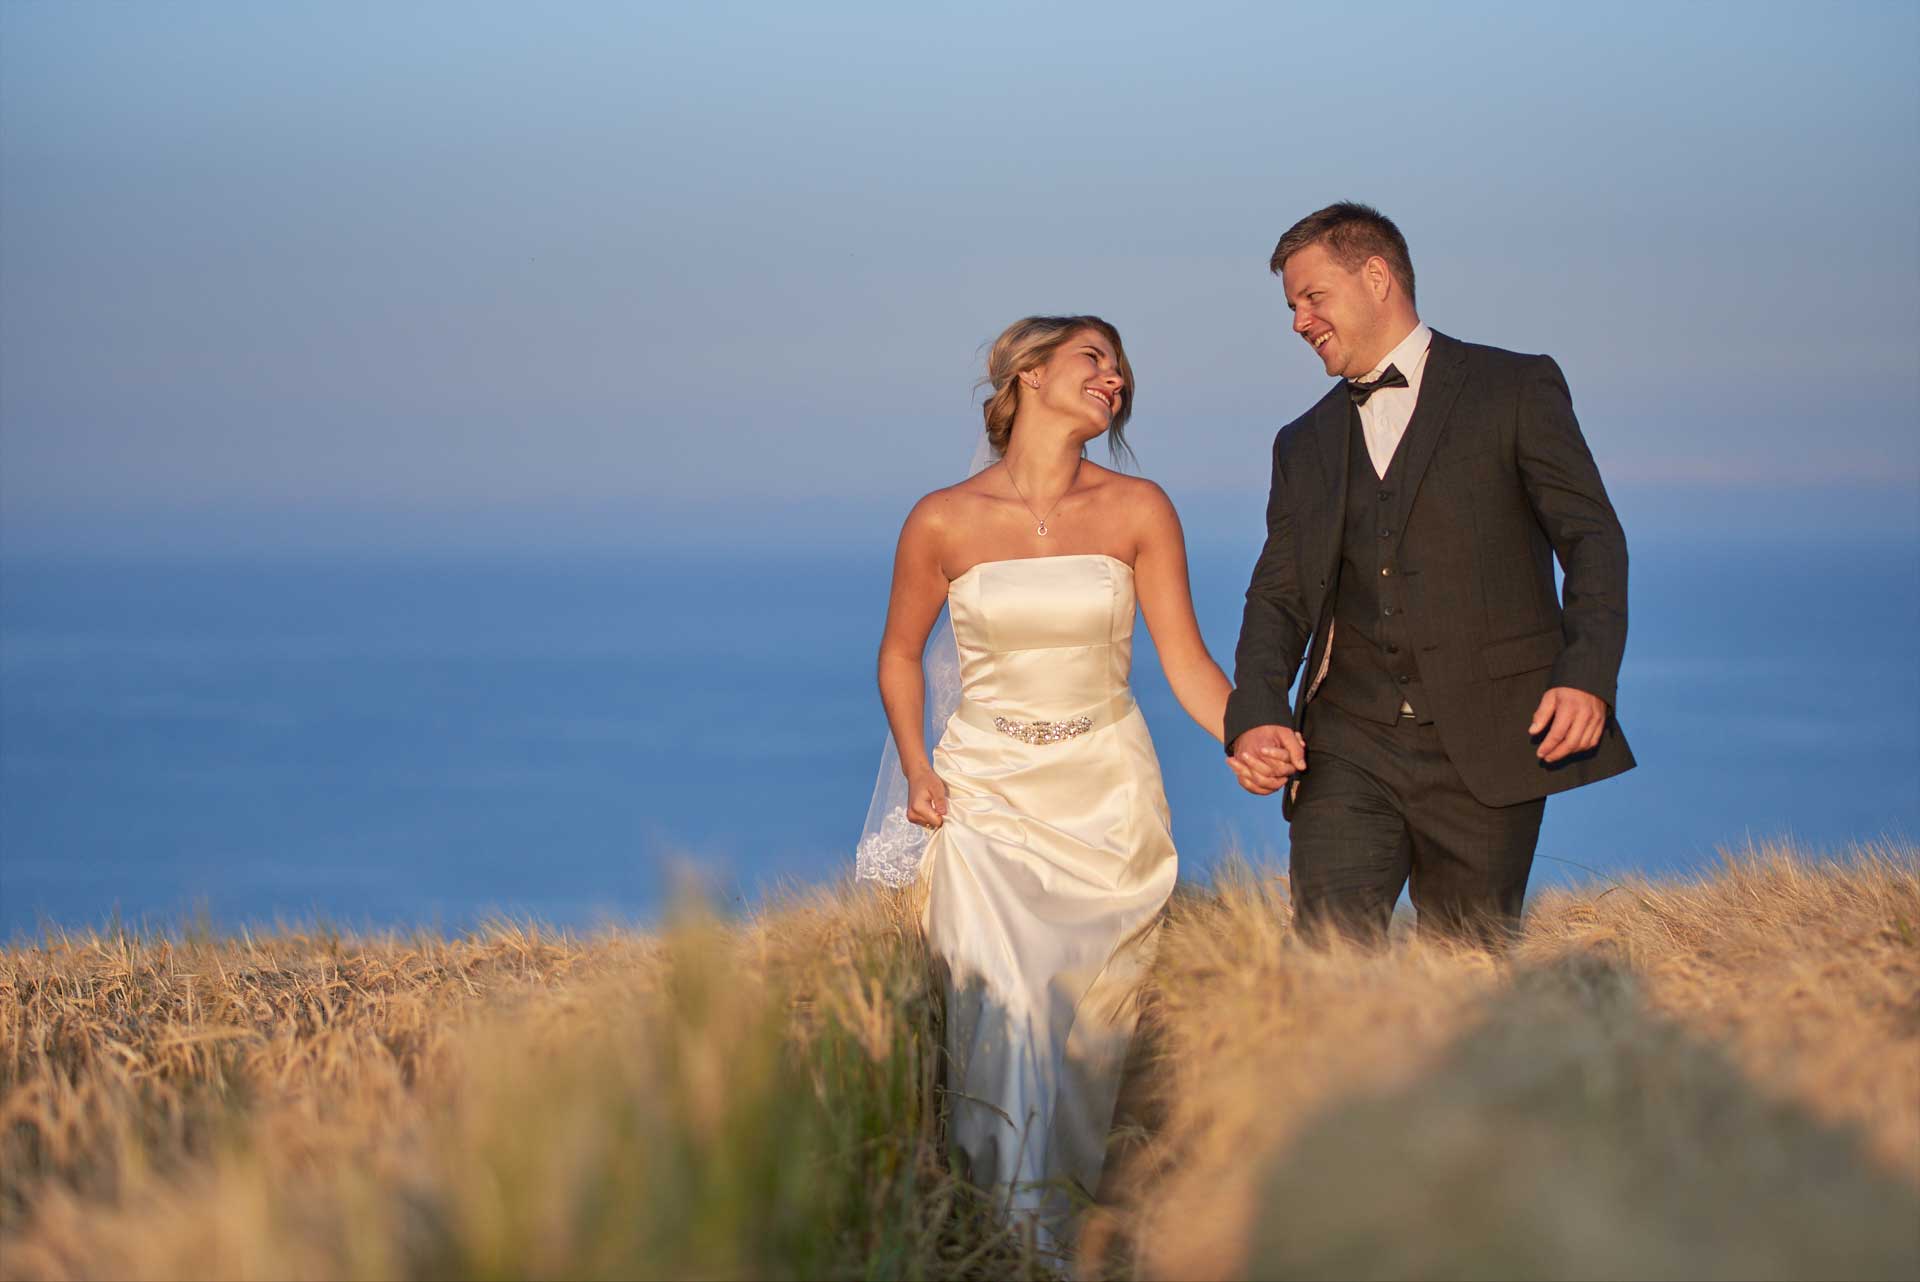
[{"xmin": 879, "ymin": 493, "xmax": 947, "ymax": 825}]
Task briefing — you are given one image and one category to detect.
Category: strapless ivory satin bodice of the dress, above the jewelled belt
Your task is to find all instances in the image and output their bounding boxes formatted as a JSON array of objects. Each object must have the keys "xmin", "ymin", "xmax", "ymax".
[{"xmin": 947, "ymin": 553, "xmax": 1135, "ymax": 720}]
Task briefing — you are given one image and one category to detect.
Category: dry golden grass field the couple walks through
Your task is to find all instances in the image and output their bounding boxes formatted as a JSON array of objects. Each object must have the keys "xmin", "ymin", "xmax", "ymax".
[{"xmin": 0, "ymin": 846, "xmax": 1920, "ymax": 1278}]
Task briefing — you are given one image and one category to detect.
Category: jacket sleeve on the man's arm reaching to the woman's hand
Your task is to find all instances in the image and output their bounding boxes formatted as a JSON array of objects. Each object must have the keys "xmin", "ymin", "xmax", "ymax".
[{"xmin": 1225, "ymin": 438, "xmax": 1311, "ymax": 752}]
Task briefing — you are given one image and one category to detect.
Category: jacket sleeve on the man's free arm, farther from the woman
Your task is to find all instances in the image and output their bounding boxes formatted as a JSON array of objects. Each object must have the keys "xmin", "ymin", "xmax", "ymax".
[{"xmin": 1517, "ymin": 357, "xmax": 1626, "ymax": 708}]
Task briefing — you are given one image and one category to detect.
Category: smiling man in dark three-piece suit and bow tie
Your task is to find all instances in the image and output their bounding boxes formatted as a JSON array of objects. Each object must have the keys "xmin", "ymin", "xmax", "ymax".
[{"xmin": 1225, "ymin": 203, "xmax": 1634, "ymax": 946}]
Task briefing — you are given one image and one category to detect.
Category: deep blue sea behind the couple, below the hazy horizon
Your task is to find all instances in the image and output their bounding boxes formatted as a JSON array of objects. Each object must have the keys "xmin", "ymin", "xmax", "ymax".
[{"xmin": 0, "ymin": 502, "xmax": 1920, "ymax": 940}]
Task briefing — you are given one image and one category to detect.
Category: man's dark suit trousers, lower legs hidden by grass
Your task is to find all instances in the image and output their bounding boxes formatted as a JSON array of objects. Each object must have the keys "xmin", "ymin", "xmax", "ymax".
[{"xmin": 1290, "ymin": 699, "xmax": 1546, "ymax": 948}]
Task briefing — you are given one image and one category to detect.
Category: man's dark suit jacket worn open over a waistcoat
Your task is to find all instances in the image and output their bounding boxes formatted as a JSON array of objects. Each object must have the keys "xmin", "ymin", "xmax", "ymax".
[{"xmin": 1227, "ymin": 332, "xmax": 1634, "ymax": 806}]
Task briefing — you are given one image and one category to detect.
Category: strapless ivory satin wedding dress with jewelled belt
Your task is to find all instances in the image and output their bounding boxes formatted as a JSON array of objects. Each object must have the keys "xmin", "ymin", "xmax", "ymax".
[{"xmin": 922, "ymin": 555, "xmax": 1175, "ymax": 1242}]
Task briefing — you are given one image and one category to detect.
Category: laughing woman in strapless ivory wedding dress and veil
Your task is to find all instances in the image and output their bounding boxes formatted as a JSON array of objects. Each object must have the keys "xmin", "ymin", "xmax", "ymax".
[{"xmin": 860, "ymin": 317, "xmax": 1240, "ymax": 1246}]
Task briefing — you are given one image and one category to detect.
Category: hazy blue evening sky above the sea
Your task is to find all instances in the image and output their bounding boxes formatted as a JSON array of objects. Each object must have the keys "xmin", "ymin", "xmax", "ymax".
[{"xmin": 0, "ymin": 2, "xmax": 1920, "ymax": 547}]
